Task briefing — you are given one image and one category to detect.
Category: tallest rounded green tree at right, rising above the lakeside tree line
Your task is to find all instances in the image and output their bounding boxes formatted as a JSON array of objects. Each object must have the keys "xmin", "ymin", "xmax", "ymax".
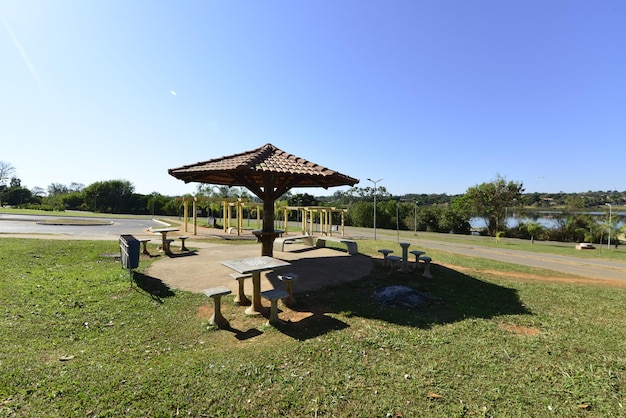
[{"xmin": 462, "ymin": 174, "xmax": 524, "ymax": 236}]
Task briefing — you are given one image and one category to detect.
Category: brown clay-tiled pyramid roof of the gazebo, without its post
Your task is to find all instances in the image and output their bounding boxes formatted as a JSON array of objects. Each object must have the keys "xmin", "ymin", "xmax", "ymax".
[{"xmin": 168, "ymin": 144, "xmax": 359, "ymax": 188}]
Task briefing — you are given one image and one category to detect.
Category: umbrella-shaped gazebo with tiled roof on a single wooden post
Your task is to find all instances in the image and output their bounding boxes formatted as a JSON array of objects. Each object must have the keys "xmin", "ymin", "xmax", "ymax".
[{"xmin": 168, "ymin": 144, "xmax": 359, "ymax": 256}]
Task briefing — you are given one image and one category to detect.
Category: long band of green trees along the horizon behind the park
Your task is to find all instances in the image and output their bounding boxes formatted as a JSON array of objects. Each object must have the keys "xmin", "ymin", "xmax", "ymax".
[{"xmin": 0, "ymin": 162, "xmax": 626, "ymax": 242}]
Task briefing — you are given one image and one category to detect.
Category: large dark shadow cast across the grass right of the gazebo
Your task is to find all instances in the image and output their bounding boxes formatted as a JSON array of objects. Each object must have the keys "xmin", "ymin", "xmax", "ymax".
[{"xmin": 260, "ymin": 263, "xmax": 532, "ymax": 340}]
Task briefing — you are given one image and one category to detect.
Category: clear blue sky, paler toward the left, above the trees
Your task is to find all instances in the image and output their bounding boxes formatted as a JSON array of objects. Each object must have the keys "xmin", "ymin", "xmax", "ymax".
[{"xmin": 0, "ymin": 0, "xmax": 626, "ymax": 195}]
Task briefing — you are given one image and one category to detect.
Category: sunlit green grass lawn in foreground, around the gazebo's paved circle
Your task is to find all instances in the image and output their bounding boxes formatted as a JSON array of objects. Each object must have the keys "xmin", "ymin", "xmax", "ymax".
[{"xmin": 0, "ymin": 238, "xmax": 626, "ymax": 417}]
